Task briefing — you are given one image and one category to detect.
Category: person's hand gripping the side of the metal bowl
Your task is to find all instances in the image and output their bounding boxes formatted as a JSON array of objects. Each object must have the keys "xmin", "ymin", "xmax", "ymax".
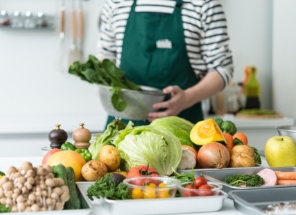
[{"xmin": 148, "ymin": 86, "xmax": 190, "ymax": 122}]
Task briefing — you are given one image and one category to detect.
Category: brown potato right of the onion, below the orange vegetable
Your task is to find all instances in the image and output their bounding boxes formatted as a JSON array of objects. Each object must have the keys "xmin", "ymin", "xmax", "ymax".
[{"xmin": 230, "ymin": 145, "xmax": 256, "ymax": 167}]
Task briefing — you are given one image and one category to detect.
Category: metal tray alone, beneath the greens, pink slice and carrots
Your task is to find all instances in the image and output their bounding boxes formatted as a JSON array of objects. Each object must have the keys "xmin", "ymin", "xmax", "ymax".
[{"xmin": 200, "ymin": 167, "xmax": 296, "ymax": 192}]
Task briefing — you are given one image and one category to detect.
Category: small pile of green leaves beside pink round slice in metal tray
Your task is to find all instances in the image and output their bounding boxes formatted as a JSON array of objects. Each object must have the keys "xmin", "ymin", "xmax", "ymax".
[{"xmin": 225, "ymin": 174, "xmax": 264, "ymax": 187}]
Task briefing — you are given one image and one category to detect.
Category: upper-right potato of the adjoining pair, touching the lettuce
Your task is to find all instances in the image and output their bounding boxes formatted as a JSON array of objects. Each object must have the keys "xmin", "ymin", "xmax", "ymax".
[{"xmin": 99, "ymin": 145, "xmax": 121, "ymax": 172}]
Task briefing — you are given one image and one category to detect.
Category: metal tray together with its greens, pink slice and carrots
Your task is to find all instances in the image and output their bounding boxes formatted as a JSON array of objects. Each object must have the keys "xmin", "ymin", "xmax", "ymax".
[{"xmin": 199, "ymin": 167, "xmax": 296, "ymax": 193}]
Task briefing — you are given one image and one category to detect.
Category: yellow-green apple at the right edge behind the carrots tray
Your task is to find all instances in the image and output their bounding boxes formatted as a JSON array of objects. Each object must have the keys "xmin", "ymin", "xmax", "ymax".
[{"xmin": 264, "ymin": 136, "xmax": 296, "ymax": 167}]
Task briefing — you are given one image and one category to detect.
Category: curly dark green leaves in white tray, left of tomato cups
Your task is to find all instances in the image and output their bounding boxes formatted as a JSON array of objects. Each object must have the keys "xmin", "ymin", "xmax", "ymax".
[{"xmin": 86, "ymin": 173, "xmax": 131, "ymax": 201}]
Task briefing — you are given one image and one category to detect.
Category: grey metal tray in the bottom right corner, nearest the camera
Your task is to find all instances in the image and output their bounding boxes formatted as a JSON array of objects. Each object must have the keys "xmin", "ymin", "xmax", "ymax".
[{"xmin": 228, "ymin": 186, "xmax": 296, "ymax": 215}]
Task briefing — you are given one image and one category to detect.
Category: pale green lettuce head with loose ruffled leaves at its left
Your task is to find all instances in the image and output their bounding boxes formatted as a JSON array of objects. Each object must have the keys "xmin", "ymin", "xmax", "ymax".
[{"xmin": 90, "ymin": 117, "xmax": 186, "ymax": 175}]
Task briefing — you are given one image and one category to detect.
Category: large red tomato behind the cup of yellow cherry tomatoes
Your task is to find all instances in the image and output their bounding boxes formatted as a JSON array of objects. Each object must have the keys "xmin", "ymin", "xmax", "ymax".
[{"xmin": 126, "ymin": 165, "xmax": 160, "ymax": 186}]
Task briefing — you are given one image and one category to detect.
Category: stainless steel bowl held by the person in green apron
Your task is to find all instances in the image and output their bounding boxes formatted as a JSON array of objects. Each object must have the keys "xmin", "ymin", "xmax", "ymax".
[{"xmin": 99, "ymin": 85, "xmax": 165, "ymax": 120}]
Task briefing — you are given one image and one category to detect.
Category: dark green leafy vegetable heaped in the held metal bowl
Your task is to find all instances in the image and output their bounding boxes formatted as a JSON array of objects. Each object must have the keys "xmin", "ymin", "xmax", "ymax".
[{"xmin": 68, "ymin": 55, "xmax": 140, "ymax": 112}]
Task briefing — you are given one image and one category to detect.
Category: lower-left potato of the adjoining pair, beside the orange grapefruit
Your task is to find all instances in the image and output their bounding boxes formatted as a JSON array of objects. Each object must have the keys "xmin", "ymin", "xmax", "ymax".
[{"xmin": 81, "ymin": 160, "xmax": 108, "ymax": 181}]
